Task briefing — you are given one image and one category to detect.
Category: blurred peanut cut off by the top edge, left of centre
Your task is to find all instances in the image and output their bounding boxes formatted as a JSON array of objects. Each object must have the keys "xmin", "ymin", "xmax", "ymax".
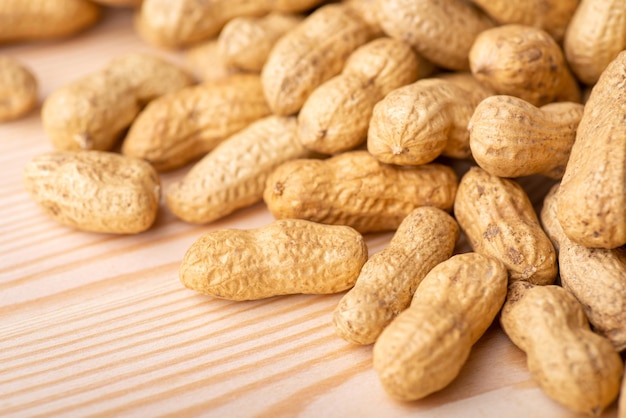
[{"xmin": 135, "ymin": 0, "xmax": 323, "ymax": 48}]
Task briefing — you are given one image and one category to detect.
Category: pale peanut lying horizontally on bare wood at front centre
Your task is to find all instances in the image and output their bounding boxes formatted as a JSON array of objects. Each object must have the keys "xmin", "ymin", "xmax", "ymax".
[{"xmin": 180, "ymin": 219, "xmax": 367, "ymax": 300}]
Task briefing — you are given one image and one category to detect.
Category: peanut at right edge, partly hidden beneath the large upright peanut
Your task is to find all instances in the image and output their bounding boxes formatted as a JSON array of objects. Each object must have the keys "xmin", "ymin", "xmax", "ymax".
[{"xmin": 541, "ymin": 185, "xmax": 626, "ymax": 351}]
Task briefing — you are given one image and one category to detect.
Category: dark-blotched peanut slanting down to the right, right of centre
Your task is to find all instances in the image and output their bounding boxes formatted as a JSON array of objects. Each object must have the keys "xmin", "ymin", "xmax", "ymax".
[{"xmin": 454, "ymin": 167, "xmax": 557, "ymax": 284}]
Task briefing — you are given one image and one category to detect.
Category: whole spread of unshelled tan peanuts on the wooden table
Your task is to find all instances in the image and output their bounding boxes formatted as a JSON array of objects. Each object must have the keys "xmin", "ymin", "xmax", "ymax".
[{"xmin": 0, "ymin": 0, "xmax": 626, "ymax": 417}]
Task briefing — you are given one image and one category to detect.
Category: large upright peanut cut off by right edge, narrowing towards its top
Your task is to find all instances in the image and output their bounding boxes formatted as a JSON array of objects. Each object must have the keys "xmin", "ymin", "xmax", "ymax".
[{"xmin": 558, "ymin": 52, "xmax": 626, "ymax": 249}]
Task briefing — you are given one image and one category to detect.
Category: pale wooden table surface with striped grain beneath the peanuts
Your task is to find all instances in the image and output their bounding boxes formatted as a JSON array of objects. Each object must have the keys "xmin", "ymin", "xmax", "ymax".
[{"xmin": 0, "ymin": 10, "xmax": 616, "ymax": 418}]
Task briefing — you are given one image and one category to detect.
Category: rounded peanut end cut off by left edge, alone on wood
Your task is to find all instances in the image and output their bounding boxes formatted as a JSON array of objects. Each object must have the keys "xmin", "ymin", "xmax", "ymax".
[{"xmin": 0, "ymin": 56, "xmax": 39, "ymax": 122}]
